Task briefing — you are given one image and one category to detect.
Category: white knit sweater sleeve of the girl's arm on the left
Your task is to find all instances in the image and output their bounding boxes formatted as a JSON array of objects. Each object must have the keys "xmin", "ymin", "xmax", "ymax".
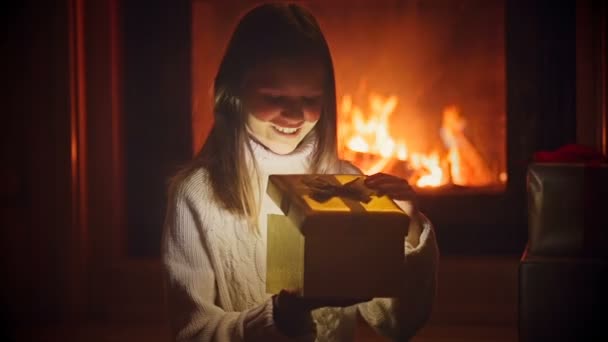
[{"xmin": 162, "ymin": 180, "xmax": 314, "ymax": 342}]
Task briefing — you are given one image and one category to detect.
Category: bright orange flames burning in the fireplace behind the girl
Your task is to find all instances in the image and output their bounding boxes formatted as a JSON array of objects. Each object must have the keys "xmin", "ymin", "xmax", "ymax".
[{"xmin": 338, "ymin": 93, "xmax": 496, "ymax": 187}]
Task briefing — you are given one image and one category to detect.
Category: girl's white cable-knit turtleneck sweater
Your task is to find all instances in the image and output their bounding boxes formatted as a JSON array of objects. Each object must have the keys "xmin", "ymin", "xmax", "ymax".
[{"xmin": 162, "ymin": 137, "xmax": 438, "ymax": 342}]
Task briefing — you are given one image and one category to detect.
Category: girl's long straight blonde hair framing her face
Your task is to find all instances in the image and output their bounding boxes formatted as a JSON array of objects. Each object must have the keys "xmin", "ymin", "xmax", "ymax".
[{"xmin": 174, "ymin": 4, "xmax": 337, "ymax": 224}]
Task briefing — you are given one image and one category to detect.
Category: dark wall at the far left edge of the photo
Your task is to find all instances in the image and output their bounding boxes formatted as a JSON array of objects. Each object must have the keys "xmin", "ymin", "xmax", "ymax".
[{"xmin": 0, "ymin": 2, "xmax": 72, "ymax": 326}]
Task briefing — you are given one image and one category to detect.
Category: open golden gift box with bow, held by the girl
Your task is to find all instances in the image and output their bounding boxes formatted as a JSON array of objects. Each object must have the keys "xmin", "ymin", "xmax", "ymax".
[{"xmin": 266, "ymin": 175, "xmax": 409, "ymax": 298}]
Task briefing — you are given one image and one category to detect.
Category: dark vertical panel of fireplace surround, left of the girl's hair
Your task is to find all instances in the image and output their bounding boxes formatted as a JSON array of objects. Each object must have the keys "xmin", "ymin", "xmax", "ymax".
[{"xmin": 122, "ymin": 0, "xmax": 192, "ymax": 257}]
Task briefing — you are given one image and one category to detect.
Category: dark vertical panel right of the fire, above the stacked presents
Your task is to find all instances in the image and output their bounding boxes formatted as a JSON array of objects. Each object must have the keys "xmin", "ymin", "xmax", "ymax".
[{"xmin": 507, "ymin": 0, "xmax": 576, "ymax": 154}]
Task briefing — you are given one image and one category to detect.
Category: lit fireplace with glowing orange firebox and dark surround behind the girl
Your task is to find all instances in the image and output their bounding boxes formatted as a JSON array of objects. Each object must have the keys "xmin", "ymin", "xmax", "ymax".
[{"xmin": 123, "ymin": 0, "xmax": 606, "ymax": 256}]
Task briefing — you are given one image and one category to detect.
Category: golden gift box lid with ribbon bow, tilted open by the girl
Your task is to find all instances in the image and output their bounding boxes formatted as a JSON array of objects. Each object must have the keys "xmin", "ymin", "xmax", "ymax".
[{"xmin": 267, "ymin": 175, "xmax": 409, "ymax": 235}]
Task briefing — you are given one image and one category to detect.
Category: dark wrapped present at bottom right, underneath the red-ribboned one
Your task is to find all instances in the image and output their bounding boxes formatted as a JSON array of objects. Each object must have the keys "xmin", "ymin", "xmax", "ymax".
[{"xmin": 517, "ymin": 253, "xmax": 608, "ymax": 342}]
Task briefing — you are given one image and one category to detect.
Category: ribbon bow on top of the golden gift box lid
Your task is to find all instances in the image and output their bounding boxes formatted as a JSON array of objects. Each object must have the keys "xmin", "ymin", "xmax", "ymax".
[{"xmin": 302, "ymin": 177, "xmax": 374, "ymax": 203}]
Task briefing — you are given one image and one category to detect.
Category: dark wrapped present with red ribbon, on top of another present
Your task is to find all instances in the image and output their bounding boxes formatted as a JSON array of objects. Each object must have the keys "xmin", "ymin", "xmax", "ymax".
[{"xmin": 527, "ymin": 161, "xmax": 608, "ymax": 257}]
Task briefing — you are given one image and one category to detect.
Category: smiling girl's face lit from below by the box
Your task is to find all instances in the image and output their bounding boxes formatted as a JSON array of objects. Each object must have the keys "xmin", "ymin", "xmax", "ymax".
[{"xmin": 244, "ymin": 61, "xmax": 325, "ymax": 154}]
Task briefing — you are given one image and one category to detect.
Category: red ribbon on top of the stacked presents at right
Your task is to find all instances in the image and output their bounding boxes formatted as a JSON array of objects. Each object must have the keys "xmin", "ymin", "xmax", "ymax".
[{"xmin": 534, "ymin": 144, "xmax": 608, "ymax": 165}]
